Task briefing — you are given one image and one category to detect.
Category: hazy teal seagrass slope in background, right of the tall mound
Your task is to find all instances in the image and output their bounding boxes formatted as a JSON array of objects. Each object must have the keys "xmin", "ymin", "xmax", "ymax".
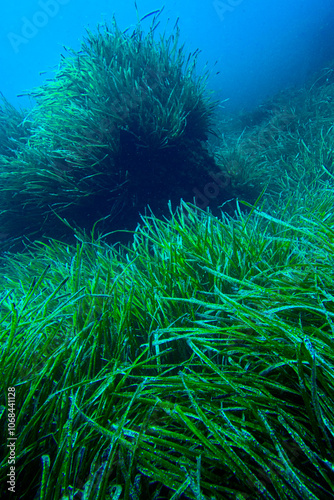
[{"xmin": 215, "ymin": 65, "xmax": 334, "ymax": 209}]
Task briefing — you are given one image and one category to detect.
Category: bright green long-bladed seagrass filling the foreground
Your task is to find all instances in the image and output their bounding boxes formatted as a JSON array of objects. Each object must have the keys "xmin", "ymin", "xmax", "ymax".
[{"xmin": 0, "ymin": 193, "xmax": 334, "ymax": 499}]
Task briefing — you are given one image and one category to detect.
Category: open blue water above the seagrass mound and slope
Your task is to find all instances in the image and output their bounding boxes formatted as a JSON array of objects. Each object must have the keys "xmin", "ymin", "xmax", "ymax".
[{"xmin": 0, "ymin": 0, "xmax": 334, "ymax": 111}]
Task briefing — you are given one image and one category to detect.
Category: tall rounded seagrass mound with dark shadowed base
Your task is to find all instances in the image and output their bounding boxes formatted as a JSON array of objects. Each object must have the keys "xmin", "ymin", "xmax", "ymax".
[{"xmin": 0, "ymin": 11, "xmax": 214, "ymax": 244}]
